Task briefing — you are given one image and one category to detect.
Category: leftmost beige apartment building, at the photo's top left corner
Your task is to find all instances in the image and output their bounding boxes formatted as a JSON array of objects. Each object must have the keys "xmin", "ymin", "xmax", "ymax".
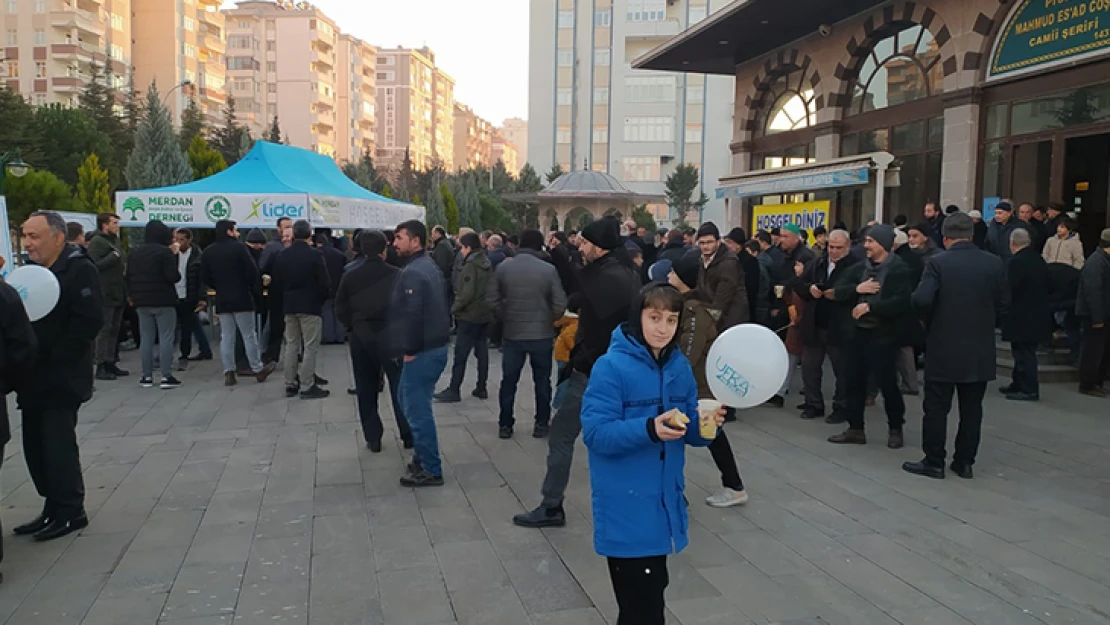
[{"xmin": 0, "ymin": 0, "xmax": 132, "ymax": 105}]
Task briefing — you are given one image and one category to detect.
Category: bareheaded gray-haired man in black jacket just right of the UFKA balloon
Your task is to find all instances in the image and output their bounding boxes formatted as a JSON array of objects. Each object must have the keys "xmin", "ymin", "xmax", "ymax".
[{"xmin": 794, "ymin": 230, "xmax": 859, "ymax": 424}]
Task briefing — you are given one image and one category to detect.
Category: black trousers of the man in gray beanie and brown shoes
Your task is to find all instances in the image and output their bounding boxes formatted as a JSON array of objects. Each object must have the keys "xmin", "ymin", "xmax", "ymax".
[{"xmin": 845, "ymin": 330, "xmax": 906, "ymax": 430}]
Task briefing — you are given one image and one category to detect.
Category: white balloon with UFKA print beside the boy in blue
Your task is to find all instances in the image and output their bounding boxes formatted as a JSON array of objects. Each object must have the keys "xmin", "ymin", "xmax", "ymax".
[{"xmin": 705, "ymin": 323, "xmax": 789, "ymax": 409}]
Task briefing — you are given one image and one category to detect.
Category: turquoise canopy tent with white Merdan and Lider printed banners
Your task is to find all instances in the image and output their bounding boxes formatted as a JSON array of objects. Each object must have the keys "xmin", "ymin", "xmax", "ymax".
[{"xmin": 115, "ymin": 141, "xmax": 424, "ymax": 229}]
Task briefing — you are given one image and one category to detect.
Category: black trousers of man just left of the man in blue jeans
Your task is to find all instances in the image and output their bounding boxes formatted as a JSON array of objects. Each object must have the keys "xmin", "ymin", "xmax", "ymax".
[{"xmin": 347, "ymin": 334, "xmax": 413, "ymax": 443}]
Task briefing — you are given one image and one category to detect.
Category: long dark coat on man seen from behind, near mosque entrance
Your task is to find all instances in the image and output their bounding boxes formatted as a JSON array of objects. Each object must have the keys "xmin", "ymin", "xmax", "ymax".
[{"xmin": 914, "ymin": 241, "xmax": 1010, "ymax": 384}]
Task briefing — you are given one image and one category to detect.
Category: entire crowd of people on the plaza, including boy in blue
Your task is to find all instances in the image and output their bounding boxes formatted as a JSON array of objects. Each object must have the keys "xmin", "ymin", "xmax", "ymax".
[{"xmin": 0, "ymin": 202, "xmax": 1110, "ymax": 623}]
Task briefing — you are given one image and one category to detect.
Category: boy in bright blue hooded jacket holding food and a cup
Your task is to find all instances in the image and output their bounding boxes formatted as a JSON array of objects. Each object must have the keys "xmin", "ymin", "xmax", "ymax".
[{"xmin": 582, "ymin": 284, "xmax": 725, "ymax": 625}]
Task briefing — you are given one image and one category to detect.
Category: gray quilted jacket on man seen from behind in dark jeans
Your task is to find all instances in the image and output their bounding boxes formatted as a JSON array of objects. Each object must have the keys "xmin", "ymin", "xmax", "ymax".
[{"xmin": 486, "ymin": 249, "xmax": 566, "ymax": 341}]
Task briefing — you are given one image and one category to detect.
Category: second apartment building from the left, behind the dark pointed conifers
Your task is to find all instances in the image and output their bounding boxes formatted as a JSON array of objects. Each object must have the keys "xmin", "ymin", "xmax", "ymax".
[{"xmin": 130, "ymin": 0, "xmax": 228, "ymax": 124}]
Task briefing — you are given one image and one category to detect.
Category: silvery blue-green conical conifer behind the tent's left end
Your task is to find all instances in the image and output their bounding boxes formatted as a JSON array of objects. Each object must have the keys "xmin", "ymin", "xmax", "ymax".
[{"xmin": 124, "ymin": 82, "xmax": 193, "ymax": 190}]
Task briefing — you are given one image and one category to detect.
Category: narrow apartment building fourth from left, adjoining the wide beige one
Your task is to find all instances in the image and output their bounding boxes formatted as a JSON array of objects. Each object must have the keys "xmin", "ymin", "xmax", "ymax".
[{"xmin": 335, "ymin": 34, "xmax": 377, "ymax": 161}]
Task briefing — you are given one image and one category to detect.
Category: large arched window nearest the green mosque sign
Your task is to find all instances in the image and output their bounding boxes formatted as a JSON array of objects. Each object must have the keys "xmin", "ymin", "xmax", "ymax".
[{"xmin": 849, "ymin": 22, "xmax": 944, "ymax": 114}]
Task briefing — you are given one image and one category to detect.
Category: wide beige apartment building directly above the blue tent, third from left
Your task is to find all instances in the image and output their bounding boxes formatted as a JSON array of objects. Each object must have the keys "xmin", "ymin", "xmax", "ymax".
[{"xmin": 224, "ymin": 0, "xmax": 340, "ymax": 157}]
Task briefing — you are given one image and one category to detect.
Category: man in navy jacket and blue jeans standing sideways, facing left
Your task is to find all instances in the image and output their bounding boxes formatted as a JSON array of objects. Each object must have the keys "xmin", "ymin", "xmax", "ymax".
[{"xmin": 391, "ymin": 220, "xmax": 451, "ymax": 487}]
